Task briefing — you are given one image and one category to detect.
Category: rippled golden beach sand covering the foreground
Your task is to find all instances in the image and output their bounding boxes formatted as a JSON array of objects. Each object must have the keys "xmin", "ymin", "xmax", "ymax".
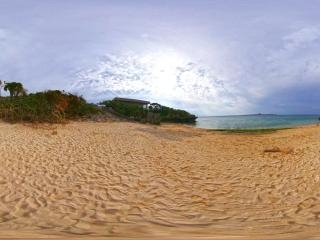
[{"xmin": 0, "ymin": 122, "xmax": 320, "ymax": 239}]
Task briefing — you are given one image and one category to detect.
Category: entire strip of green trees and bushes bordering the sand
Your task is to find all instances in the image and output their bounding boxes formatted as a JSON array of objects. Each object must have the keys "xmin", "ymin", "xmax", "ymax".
[{"xmin": 0, "ymin": 80, "xmax": 196, "ymax": 124}]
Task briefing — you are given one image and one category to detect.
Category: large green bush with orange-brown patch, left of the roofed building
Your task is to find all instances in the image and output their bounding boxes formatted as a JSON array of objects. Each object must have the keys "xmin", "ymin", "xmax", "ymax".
[{"xmin": 0, "ymin": 90, "xmax": 100, "ymax": 123}]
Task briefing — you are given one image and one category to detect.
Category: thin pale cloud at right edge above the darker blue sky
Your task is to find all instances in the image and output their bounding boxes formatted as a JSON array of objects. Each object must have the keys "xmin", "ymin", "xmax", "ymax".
[{"xmin": 247, "ymin": 26, "xmax": 320, "ymax": 101}]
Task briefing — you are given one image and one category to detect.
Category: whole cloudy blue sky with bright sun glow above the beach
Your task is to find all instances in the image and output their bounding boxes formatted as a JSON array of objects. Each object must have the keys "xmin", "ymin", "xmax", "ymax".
[{"xmin": 0, "ymin": 0, "xmax": 320, "ymax": 116}]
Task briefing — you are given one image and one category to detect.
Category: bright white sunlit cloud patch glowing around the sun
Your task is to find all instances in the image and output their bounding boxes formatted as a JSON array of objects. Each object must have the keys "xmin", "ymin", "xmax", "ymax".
[{"xmin": 70, "ymin": 51, "xmax": 248, "ymax": 114}]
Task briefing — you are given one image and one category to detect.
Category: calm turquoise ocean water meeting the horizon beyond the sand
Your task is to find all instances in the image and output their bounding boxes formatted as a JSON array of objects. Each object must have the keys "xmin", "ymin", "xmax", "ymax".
[{"xmin": 196, "ymin": 114, "xmax": 320, "ymax": 129}]
